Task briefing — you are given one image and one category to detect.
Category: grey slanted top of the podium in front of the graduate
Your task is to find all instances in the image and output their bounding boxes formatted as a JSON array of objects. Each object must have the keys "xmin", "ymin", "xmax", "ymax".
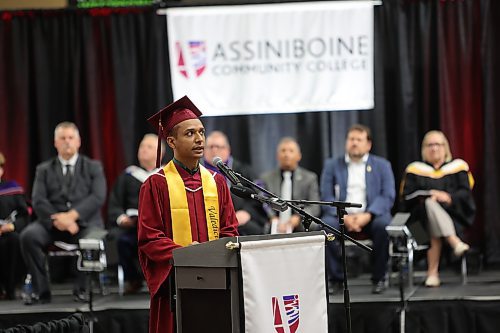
[{"xmin": 173, "ymin": 231, "xmax": 324, "ymax": 267}]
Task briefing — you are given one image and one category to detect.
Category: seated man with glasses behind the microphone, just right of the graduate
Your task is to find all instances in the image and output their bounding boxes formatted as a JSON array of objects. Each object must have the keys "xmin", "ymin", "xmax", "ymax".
[{"xmin": 203, "ymin": 131, "xmax": 267, "ymax": 236}]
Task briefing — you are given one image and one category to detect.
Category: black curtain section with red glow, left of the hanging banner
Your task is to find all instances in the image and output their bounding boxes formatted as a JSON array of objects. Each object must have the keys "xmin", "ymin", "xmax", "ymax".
[{"xmin": 0, "ymin": 8, "xmax": 172, "ymax": 189}]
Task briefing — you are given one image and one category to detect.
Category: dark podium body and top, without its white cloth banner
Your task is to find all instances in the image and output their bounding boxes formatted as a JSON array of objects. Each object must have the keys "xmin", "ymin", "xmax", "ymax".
[{"xmin": 173, "ymin": 231, "xmax": 324, "ymax": 333}]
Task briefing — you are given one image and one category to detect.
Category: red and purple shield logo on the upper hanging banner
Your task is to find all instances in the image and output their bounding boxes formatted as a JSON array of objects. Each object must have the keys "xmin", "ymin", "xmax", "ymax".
[{"xmin": 175, "ymin": 41, "xmax": 207, "ymax": 79}]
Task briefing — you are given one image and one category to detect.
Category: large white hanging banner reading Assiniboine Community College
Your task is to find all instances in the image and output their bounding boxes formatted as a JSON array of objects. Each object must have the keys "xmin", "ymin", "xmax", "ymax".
[{"xmin": 166, "ymin": 1, "xmax": 374, "ymax": 116}]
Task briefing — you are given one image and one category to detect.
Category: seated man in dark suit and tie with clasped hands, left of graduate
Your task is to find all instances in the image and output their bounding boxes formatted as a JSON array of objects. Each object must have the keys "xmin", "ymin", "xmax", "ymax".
[{"xmin": 21, "ymin": 122, "xmax": 106, "ymax": 304}]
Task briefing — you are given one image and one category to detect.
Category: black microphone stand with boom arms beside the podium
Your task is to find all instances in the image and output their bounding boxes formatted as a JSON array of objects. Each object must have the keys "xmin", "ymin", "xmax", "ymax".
[{"xmin": 235, "ymin": 172, "xmax": 372, "ymax": 333}]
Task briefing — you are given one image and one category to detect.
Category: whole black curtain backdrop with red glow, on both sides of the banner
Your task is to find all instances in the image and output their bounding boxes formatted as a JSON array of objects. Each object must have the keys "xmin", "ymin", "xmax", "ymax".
[{"xmin": 0, "ymin": 0, "xmax": 500, "ymax": 263}]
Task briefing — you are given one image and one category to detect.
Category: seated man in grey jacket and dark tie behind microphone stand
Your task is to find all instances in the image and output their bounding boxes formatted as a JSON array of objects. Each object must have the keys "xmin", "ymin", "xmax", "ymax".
[{"xmin": 260, "ymin": 137, "xmax": 321, "ymax": 233}]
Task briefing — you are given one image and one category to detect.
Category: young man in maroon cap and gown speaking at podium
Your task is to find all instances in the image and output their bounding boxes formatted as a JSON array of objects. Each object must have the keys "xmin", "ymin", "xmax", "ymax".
[{"xmin": 138, "ymin": 96, "xmax": 238, "ymax": 333}]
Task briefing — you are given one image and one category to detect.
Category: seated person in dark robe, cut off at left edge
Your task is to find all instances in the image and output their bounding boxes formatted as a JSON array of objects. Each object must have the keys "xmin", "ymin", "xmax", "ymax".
[{"xmin": 0, "ymin": 153, "xmax": 28, "ymax": 299}]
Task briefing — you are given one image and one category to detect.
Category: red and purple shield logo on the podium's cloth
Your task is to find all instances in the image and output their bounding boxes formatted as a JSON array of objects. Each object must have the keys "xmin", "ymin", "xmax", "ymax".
[{"xmin": 272, "ymin": 295, "xmax": 300, "ymax": 333}]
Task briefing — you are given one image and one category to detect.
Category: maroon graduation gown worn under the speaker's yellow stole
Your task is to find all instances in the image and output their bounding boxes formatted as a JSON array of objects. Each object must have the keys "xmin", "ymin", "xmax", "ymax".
[{"xmin": 137, "ymin": 165, "xmax": 238, "ymax": 333}]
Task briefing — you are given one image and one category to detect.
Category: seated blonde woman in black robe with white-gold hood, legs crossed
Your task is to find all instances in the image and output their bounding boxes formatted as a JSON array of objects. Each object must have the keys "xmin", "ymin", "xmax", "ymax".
[{"xmin": 401, "ymin": 131, "xmax": 476, "ymax": 287}]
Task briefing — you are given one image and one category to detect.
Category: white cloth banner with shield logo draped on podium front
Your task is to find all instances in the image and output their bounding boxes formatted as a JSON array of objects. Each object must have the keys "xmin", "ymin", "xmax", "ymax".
[{"xmin": 240, "ymin": 235, "xmax": 328, "ymax": 333}]
